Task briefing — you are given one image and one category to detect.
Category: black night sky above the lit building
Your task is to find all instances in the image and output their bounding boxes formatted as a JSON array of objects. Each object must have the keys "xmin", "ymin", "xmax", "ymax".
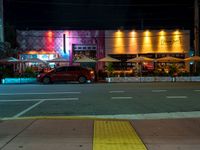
[{"xmin": 4, "ymin": 0, "xmax": 194, "ymax": 29}]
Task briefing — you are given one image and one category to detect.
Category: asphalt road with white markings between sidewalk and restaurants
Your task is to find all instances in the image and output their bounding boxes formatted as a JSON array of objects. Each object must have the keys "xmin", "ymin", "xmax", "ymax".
[{"xmin": 0, "ymin": 83, "xmax": 200, "ymax": 119}]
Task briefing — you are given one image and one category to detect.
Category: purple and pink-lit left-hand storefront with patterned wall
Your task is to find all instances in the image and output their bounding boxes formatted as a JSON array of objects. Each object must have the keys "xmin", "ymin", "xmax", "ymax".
[{"xmin": 17, "ymin": 30, "xmax": 105, "ymax": 64}]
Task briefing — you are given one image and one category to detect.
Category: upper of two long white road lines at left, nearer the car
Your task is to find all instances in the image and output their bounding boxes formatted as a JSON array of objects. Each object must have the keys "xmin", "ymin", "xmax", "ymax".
[{"xmin": 0, "ymin": 92, "xmax": 81, "ymax": 96}]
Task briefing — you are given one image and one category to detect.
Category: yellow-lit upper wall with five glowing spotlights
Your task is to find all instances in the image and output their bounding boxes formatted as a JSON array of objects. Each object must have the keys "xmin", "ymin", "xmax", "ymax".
[{"xmin": 105, "ymin": 30, "xmax": 190, "ymax": 54}]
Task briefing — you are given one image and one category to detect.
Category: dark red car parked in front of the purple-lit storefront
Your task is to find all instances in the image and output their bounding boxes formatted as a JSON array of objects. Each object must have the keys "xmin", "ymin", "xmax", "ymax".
[{"xmin": 37, "ymin": 66, "xmax": 95, "ymax": 84}]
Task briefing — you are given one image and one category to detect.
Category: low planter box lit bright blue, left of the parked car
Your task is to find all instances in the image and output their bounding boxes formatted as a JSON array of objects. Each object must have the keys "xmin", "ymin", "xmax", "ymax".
[{"xmin": 2, "ymin": 78, "xmax": 37, "ymax": 84}]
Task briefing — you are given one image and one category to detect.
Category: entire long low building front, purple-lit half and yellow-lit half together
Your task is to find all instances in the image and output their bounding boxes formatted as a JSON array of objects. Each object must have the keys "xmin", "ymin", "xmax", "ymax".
[{"xmin": 17, "ymin": 30, "xmax": 190, "ymax": 70}]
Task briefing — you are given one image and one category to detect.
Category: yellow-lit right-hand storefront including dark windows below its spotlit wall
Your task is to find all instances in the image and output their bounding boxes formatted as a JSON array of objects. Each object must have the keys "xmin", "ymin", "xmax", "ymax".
[{"xmin": 105, "ymin": 30, "xmax": 190, "ymax": 73}]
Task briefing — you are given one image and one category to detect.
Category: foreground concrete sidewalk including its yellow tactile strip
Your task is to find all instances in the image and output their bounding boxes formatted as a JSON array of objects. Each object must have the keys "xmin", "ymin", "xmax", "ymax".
[{"xmin": 0, "ymin": 119, "xmax": 200, "ymax": 150}]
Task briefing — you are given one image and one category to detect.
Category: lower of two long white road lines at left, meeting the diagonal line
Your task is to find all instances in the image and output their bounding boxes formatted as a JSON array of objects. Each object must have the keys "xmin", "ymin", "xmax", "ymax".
[{"xmin": 0, "ymin": 97, "xmax": 79, "ymax": 102}]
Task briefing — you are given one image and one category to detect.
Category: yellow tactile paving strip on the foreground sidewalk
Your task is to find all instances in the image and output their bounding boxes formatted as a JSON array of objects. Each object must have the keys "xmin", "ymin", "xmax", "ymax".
[{"xmin": 93, "ymin": 121, "xmax": 146, "ymax": 150}]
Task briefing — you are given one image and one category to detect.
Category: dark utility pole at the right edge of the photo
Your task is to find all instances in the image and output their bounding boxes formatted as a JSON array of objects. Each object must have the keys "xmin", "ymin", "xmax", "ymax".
[{"xmin": 194, "ymin": 0, "xmax": 199, "ymax": 55}]
